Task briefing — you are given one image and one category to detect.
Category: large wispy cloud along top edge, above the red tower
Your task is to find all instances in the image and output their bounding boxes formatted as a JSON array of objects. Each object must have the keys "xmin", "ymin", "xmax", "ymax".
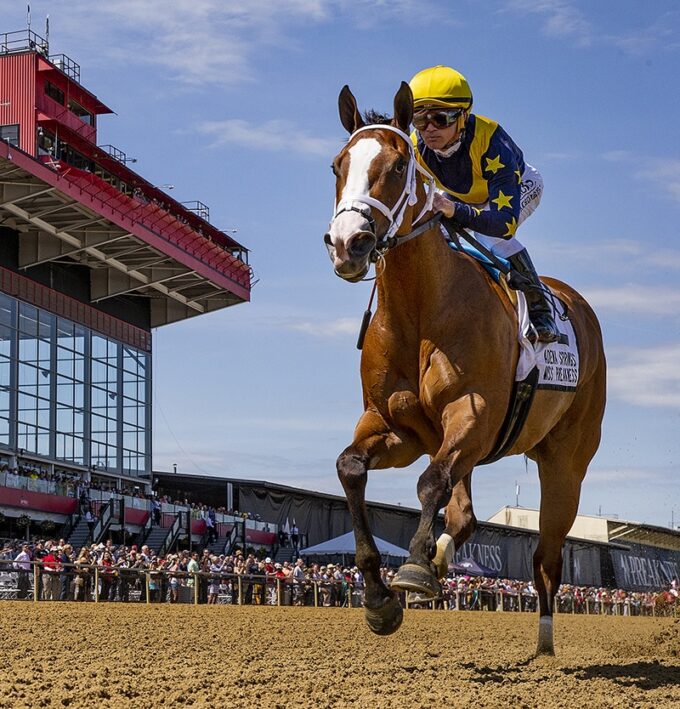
[{"xmin": 33, "ymin": 0, "xmax": 433, "ymax": 87}]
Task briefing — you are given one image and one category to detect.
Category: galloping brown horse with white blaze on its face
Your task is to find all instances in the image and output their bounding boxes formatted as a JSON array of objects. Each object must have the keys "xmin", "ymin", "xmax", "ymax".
[{"xmin": 324, "ymin": 83, "xmax": 606, "ymax": 653}]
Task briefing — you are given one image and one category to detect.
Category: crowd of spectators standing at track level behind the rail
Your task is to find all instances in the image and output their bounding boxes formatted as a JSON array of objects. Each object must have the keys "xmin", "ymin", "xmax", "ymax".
[{"xmin": 0, "ymin": 539, "xmax": 680, "ymax": 615}]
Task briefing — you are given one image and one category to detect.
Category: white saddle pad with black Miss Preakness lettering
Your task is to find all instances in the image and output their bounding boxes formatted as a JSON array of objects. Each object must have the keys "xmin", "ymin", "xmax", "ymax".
[{"xmin": 515, "ymin": 291, "xmax": 579, "ymax": 392}]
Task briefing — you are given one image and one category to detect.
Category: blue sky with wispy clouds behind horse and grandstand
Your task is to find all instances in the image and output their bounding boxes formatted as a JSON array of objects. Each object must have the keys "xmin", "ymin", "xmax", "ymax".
[{"xmin": 0, "ymin": 0, "xmax": 680, "ymax": 526}]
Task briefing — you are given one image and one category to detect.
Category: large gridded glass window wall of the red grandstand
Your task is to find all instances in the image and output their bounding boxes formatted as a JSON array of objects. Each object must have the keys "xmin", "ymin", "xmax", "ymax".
[{"xmin": 0, "ymin": 293, "xmax": 151, "ymax": 474}]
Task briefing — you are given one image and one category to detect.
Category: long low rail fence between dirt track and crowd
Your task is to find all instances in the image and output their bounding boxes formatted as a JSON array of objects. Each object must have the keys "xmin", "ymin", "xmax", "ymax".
[{"xmin": 0, "ymin": 561, "xmax": 680, "ymax": 617}]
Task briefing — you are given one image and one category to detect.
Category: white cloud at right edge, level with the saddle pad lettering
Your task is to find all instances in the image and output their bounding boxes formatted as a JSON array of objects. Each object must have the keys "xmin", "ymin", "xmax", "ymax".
[{"xmin": 607, "ymin": 343, "xmax": 680, "ymax": 409}]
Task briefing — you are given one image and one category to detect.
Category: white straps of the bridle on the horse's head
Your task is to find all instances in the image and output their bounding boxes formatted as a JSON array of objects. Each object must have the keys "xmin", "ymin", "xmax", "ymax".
[{"xmin": 331, "ymin": 124, "xmax": 434, "ymax": 244}]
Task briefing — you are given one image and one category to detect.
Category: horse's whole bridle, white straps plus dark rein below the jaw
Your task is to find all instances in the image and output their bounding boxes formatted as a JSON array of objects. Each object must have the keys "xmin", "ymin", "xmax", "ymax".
[{"xmin": 331, "ymin": 124, "xmax": 441, "ymax": 262}]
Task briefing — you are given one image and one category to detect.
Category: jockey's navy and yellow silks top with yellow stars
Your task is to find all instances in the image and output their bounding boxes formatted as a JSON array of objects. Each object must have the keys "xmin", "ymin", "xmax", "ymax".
[{"xmin": 411, "ymin": 114, "xmax": 525, "ymax": 239}]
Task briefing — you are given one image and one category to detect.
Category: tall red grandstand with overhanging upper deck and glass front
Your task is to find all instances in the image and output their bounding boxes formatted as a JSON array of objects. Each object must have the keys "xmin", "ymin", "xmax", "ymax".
[{"xmin": 0, "ymin": 30, "xmax": 252, "ymax": 544}]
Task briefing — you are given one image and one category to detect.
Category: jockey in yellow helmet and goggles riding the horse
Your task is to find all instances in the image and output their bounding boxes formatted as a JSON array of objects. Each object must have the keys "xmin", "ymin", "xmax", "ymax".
[{"xmin": 410, "ymin": 66, "xmax": 559, "ymax": 342}]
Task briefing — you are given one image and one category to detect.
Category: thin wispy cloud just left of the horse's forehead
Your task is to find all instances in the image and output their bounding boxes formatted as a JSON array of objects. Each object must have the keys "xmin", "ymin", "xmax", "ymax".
[{"xmin": 197, "ymin": 118, "xmax": 341, "ymax": 157}]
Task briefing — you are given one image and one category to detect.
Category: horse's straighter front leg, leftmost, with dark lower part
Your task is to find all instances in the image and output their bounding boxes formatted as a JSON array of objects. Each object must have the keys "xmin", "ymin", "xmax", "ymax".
[{"xmin": 337, "ymin": 412, "xmax": 423, "ymax": 635}]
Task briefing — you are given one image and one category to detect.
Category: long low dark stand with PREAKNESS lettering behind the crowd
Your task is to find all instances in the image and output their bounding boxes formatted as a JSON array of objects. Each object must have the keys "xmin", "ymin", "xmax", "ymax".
[{"xmin": 153, "ymin": 472, "xmax": 680, "ymax": 591}]
